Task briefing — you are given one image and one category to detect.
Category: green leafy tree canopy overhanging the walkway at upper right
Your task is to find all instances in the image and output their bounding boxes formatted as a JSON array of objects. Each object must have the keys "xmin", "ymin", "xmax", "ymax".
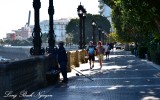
[{"xmin": 105, "ymin": 0, "xmax": 160, "ymax": 43}]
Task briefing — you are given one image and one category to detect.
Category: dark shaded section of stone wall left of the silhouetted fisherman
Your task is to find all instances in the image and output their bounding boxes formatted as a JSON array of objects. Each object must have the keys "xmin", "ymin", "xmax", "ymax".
[{"xmin": 0, "ymin": 56, "xmax": 54, "ymax": 100}]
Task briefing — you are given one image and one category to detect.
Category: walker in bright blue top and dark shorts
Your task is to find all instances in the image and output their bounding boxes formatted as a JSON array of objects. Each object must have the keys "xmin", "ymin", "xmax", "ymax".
[{"xmin": 87, "ymin": 41, "xmax": 96, "ymax": 69}]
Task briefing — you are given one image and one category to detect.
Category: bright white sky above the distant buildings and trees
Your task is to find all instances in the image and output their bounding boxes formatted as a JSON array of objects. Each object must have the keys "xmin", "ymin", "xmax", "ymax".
[{"xmin": 0, "ymin": 0, "xmax": 99, "ymax": 39}]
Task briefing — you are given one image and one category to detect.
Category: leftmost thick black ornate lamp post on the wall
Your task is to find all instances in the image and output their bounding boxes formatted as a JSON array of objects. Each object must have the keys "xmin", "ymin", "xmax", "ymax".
[{"xmin": 30, "ymin": 0, "xmax": 45, "ymax": 55}]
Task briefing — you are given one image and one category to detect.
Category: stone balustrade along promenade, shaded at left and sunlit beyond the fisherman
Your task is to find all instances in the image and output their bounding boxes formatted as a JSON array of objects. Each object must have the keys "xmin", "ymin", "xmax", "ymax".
[{"xmin": 0, "ymin": 47, "xmax": 86, "ymax": 100}]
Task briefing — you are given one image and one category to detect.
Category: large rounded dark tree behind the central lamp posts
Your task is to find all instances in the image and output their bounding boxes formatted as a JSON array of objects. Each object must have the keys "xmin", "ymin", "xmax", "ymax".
[{"xmin": 66, "ymin": 14, "xmax": 111, "ymax": 44}]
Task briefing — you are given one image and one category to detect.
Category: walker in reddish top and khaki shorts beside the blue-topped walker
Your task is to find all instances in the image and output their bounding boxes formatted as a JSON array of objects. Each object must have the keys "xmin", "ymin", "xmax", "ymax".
[{"xmin": 97, "ymin": 41, "xmax": 104, "ymax": 69}]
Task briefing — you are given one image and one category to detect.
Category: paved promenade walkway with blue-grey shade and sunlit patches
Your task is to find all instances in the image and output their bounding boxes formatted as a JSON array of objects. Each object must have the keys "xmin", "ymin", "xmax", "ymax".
[{"xmin": 24, "ymin": 50, "xmax": 160, "ymax": 100}]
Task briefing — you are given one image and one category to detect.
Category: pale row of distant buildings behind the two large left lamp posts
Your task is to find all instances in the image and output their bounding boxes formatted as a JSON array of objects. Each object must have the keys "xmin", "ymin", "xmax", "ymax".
[{"xmin": 6, "ymin": 19, "xmax": 70, "ymax": 42}]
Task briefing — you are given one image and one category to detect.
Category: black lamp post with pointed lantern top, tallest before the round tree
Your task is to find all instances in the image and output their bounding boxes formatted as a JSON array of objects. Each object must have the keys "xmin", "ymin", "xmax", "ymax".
[{"xmin": 77, "ymin": 4, "xmax": 83, "ymax": 49}]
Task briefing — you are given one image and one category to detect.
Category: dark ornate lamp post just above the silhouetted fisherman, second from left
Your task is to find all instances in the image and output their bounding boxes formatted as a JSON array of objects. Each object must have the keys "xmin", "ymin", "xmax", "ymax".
[{"xmin": 46, "ymin": 0, "xmax": 56, "ymax": 53}]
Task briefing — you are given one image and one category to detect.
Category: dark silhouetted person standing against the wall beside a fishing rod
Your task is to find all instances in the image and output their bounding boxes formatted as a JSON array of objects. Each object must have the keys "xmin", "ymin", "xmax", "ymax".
[{"xmin": 58, "ymin": 42, "xmax": 68, "ymax": 83}]
